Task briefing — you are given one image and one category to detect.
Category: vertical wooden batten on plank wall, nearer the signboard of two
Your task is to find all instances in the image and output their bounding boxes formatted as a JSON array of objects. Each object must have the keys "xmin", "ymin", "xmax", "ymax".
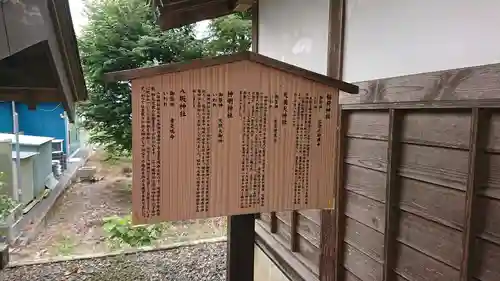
[{"xmin": 384, "ymin": 109, "xmax": 403, "ymax": 281}]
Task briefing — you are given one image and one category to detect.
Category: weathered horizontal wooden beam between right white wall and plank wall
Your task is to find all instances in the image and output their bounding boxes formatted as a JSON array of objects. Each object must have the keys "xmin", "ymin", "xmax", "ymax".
[{"xmin": 340, "ymin": 61, "xmax": 500, "ymax": 104}]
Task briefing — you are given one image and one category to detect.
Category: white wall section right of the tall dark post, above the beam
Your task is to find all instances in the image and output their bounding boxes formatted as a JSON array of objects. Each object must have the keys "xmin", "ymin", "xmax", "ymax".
[{"xmin": 343, "ymin": 0, "xmax": 500, "ymax": 82}]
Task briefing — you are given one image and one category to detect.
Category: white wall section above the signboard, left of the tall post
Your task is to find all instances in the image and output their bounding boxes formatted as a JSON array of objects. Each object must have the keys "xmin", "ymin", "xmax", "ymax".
[{"xmin": 259, "ymin": 0, "xmax": 329, "ymax": 74}]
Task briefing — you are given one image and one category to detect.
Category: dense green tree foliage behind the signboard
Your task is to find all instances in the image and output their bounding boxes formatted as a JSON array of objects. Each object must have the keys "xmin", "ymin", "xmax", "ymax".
[{"xmin": 78, "ymin": 0, "xmax": 251, "ymax": 155}]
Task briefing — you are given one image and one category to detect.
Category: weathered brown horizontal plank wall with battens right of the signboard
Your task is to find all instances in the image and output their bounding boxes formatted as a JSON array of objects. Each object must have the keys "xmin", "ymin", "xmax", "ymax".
[{"xmin": 336, "ymin": 106, "xmax": 500, "ymax": 281}]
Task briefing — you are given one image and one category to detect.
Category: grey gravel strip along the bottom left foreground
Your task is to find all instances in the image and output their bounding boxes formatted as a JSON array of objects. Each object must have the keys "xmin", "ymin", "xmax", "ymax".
[{"xmin": 0, "ymin": 243, "xmax": 226, "ymax": 281}]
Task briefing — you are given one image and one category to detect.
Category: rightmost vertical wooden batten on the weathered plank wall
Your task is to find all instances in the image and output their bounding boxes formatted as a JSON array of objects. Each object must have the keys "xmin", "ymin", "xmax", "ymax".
[{"xmin": 460, "ymin": 108, "xmax": 488, "ymax": 281}]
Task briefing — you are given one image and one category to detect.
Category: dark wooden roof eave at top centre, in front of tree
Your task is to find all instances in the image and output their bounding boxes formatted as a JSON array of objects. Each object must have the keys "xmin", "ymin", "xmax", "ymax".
[{"xmin": 152, "ymin": 0, "xmax": 253, "ymax": 30}]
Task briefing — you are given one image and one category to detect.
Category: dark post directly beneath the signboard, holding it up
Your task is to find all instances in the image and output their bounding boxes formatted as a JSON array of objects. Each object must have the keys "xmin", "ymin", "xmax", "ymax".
[{"xmin": 226, "ymin": 214, "xmax": 255, "ymax": 281}]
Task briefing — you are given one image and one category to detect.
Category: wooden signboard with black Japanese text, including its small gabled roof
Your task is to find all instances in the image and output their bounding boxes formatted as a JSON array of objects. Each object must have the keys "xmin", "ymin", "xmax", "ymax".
[{"xmin": 103, "ymin": 52, "xmax": 357, "ymax": 223}]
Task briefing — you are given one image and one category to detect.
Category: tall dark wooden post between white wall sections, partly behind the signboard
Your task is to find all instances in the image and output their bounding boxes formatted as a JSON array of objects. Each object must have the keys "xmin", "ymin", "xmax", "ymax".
[{"xmin": 319, "ymin": 0, "xmax": 345, "ymax": 281}]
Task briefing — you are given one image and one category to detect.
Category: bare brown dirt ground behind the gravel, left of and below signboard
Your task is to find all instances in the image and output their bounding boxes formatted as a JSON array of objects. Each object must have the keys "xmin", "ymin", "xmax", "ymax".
[{"xmin": 11, "ymin": 152, "xmax": 226, "ymax": 261}]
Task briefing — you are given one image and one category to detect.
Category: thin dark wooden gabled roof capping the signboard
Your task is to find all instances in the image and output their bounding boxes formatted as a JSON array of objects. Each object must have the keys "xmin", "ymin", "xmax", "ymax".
[{"xmin": 104, "ymin": 51, "xmax": 359, "ymax": 94}]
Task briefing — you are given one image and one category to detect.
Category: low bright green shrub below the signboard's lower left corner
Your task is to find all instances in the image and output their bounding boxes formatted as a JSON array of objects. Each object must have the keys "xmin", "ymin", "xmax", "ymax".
[{"xmin": 104, "ymin": 215, "xmax": 162, "ymax": 247}]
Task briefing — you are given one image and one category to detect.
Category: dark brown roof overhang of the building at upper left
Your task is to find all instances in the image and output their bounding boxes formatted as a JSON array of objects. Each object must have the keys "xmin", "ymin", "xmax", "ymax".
[{"xmin": 0, "ymin": 0, "xmax": 87, "ymax": 120}]
